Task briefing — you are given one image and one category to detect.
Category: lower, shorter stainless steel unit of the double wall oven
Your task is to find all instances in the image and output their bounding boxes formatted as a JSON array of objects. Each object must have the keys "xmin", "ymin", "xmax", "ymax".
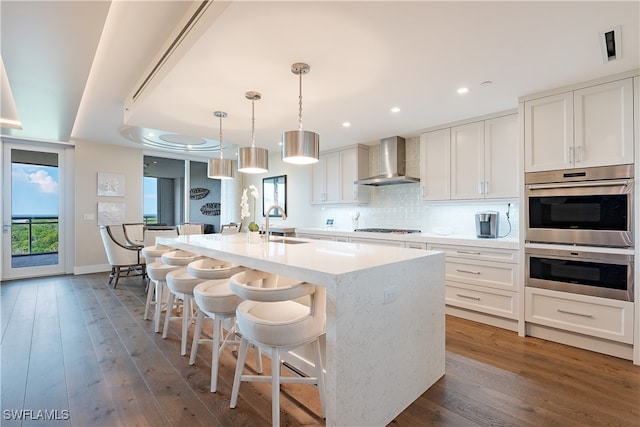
[{"xmin": 525, "ymin": 247, "xmax": 633, "ymax": 301}]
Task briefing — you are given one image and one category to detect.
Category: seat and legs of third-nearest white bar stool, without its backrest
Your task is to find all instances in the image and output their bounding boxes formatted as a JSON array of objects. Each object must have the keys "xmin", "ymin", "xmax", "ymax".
[{"xmin": 162, "ymin": 267, "xmax": 204, "ymax": 356}]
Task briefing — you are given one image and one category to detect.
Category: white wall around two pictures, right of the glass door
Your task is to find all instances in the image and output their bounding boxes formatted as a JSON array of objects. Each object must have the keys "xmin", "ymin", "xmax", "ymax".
[{"xmin": 74, "ymin": 141, "xmax": 143, "ymax": 274}]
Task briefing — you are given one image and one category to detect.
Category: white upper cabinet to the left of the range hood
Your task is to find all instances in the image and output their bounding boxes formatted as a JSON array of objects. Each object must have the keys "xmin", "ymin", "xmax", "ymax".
[{"xmin": 311, "ymin": 145, "xmax": 369, "ymax": 204}]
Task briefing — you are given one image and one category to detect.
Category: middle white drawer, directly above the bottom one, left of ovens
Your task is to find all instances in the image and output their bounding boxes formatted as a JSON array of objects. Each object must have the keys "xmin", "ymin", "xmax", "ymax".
[{"xmin": 445, "ymin": 257, "xmax": 520, "ymax": 291}]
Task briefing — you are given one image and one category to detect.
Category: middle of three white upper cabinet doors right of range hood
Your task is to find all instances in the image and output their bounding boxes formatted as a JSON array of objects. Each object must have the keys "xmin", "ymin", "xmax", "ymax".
[{"xmin": 451, "ymin": 122, "xmax": 485, "ymax": 199}]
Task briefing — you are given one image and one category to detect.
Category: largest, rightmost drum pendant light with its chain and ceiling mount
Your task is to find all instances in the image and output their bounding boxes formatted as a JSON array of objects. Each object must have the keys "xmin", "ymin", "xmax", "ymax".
[{"xmin": 282, "ymin": 62, "xmax": 320, "ymax": 165}]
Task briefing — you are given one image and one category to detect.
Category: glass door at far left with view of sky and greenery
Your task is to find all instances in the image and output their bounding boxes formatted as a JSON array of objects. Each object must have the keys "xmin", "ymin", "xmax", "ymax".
[{"xmin": 2, "ymin": 143, "xmax": 66, "ymax": 279}]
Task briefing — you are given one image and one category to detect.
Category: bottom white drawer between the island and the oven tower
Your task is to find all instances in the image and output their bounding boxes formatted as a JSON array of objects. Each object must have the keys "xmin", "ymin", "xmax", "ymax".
[{"xmin": 445, "ymin": 281, "xmax": 518, "ymax": 319}]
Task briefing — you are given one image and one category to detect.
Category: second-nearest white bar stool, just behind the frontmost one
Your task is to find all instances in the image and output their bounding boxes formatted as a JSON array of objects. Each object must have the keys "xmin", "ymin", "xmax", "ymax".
[{"xmin": 187, "ymin": 258, "xmax": 262, "ymax": 393}]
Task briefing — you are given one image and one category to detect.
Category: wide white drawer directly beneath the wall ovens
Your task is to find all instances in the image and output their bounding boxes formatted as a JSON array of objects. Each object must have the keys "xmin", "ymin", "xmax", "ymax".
[{"xmin": 525, "ymin": 288, "xmax": 633, "ymax": 344}]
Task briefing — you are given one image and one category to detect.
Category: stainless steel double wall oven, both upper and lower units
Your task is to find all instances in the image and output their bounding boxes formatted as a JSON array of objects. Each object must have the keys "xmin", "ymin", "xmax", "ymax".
[{"xmin": 525, "ymin": 165, "xmax": 634, "ymax": 301}]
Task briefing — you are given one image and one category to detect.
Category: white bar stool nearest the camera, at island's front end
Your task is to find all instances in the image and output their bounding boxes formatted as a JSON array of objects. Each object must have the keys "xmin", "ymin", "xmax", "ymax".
[{"xmin": 229, "ymin": 270, "xmax": 326, "ymax": 426}]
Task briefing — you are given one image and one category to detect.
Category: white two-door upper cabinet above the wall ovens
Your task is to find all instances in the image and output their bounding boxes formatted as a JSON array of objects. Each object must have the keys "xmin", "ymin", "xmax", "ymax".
[{"xmin": 524, "ymin": 78, "xmax": 633, "ymax": 172}]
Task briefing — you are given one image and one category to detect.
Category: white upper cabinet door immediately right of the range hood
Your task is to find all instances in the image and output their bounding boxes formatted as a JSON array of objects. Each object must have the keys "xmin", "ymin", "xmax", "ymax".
[{"xmin": 420, "ymin": 128, "xmax": 451, "ymax": 200}]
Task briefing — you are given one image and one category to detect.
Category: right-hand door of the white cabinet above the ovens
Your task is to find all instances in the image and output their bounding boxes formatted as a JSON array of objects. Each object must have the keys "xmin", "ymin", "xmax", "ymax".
[{"xmin": 573, "ymin": 78, "xmax": 633, "ymax": 167}]
